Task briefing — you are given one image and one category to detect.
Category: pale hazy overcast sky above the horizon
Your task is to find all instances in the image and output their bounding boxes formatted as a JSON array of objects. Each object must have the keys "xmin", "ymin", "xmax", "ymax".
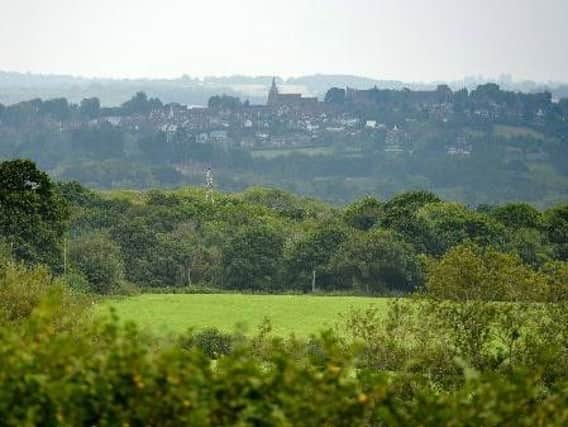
[{"xmin": 0, "ymin": 0, "xmax": 568, "ymax": 82}]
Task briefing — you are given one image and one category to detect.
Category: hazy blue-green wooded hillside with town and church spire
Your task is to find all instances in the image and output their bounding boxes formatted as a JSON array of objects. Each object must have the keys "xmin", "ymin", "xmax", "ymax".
[{"xmin": 0, "ymin": 78, "xmax": 568, "ymax": 205}]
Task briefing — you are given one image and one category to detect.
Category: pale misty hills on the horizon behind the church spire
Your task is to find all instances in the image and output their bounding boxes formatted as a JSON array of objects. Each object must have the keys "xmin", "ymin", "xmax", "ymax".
[{"xmin": 0, "ymin": 71, "xmax": 568, "ymax": 107}]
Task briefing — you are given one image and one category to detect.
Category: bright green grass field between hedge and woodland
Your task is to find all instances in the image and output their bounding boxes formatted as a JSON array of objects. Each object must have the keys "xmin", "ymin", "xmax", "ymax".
[{"xmin": 98, "ymin": 294, "xmax": 388, "ymax": 336}]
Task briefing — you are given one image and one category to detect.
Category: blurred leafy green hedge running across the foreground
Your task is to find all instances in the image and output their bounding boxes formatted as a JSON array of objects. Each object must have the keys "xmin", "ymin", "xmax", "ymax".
[{"xmin": 0, "ymin": 313, "xmax": 568, "ymax": 427}]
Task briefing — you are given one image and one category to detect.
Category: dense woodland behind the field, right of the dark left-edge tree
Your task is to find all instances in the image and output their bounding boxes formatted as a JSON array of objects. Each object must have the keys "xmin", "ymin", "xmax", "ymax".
[{"xmin": 53, "ymin": 180, "xmax": 568, "ymax": 293}]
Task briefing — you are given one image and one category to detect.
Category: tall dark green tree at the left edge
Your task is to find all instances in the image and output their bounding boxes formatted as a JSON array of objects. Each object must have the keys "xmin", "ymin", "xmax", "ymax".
[{"xmin": 0, "ymin": 160, "xmax": 69, "ymax": 270}]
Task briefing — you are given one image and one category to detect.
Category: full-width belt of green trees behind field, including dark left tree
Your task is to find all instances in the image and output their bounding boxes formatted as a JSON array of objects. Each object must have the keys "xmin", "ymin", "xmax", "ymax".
[{"xmin": 0, "ymin": 160, "xmax": 568, "ymax": 294}]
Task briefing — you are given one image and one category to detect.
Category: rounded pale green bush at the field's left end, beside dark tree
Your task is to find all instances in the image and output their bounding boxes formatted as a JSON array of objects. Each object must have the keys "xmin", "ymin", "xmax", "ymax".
[{"xmin": 69, "ymin": 234, "xmax": 124, "ymax": 294}]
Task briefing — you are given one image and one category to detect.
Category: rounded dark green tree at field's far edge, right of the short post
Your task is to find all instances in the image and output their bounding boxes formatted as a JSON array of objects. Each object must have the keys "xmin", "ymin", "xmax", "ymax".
[{"xmin": 331, "ymin": 230, "xmax": 421, "ymax": 293}]
